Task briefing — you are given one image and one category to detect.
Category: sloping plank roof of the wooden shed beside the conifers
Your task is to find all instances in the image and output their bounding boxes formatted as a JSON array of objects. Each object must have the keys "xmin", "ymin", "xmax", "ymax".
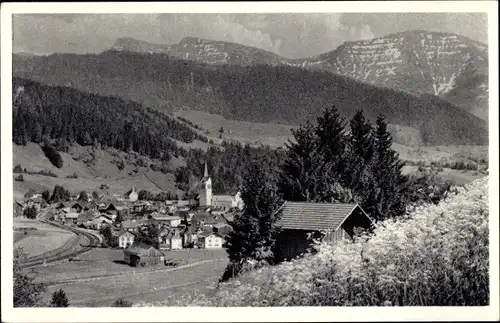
[{"xmin": 277, "ymin": 202, "xmax": 364, "ymax": 231}]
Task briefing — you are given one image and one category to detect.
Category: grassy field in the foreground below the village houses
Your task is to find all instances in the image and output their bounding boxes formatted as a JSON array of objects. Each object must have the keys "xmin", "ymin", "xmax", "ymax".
[{"xmin": 36, "ymin": 248, "xmax": 227, "ymax": 306}]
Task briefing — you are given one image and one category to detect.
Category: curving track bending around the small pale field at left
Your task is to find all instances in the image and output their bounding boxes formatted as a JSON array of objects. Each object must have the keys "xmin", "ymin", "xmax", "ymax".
[{"xmin": 21, "ymin": 208, "xmax": 100, "ymax": 268}]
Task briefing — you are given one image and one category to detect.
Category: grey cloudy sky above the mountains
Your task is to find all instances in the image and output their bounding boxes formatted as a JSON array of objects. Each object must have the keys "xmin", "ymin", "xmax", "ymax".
[{"xmin": 13, "ymin": 13, "xmax": 488, "ymax": 58}]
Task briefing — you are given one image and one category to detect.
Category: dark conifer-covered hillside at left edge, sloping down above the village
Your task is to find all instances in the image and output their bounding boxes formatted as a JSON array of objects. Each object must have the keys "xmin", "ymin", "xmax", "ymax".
[{"xmin": 12, "ymin": 78, "xmax": 206, "ymax": 158}]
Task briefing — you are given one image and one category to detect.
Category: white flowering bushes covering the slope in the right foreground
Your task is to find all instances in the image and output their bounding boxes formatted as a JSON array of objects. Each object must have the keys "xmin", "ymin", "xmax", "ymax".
[{"xmin": 136, "ymin": 178, "xmax": 489, "ymax": 306}]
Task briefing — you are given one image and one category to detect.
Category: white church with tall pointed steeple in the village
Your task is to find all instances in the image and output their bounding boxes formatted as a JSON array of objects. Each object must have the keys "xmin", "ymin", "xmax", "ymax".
[{"xmin": 198, "ymin": 163, "xmax": 244, "ymax": 211}]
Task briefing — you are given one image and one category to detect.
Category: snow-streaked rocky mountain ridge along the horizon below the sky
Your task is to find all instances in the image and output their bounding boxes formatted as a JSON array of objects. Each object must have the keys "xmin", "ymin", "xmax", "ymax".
[{"xmin": 111, "ymin": 30, "xmax": 488, "ymax": 119}]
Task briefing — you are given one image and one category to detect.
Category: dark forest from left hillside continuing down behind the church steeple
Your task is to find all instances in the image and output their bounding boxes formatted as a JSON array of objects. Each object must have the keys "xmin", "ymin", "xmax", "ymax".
[{"xmin": 13, "ymin": 78, "xmax": 282, "ymax": 193}]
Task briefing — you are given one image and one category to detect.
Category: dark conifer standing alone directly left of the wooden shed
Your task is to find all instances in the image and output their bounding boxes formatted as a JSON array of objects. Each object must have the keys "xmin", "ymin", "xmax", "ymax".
[{"xmin": 221, "ymin": 161, "xmax": 283, "ymax": 281}]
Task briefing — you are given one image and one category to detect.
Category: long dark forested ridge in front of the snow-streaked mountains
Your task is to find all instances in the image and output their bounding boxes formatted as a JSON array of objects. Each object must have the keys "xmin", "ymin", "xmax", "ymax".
[{"xmin": 13, "ymin": 51, "xmax": 488, "ymax": 145}]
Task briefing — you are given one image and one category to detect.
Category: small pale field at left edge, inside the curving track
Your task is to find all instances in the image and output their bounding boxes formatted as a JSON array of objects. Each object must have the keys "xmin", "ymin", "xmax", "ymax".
[{"xmin": 14, "ymin": 218, "xmax": 78, "ymax": 256}]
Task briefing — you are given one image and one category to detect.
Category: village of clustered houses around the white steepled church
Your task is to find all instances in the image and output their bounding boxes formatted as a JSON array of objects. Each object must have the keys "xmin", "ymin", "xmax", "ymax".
[{"xmin": 14, "ymin": 165, "xmax": 243, "ymax": 267}]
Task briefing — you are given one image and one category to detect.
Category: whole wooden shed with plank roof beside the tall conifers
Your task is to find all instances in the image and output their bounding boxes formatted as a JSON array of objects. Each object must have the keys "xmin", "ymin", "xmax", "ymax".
[{"xmin": 275, "ymin": 202, "xmax": 374, "ymax": 261}]
